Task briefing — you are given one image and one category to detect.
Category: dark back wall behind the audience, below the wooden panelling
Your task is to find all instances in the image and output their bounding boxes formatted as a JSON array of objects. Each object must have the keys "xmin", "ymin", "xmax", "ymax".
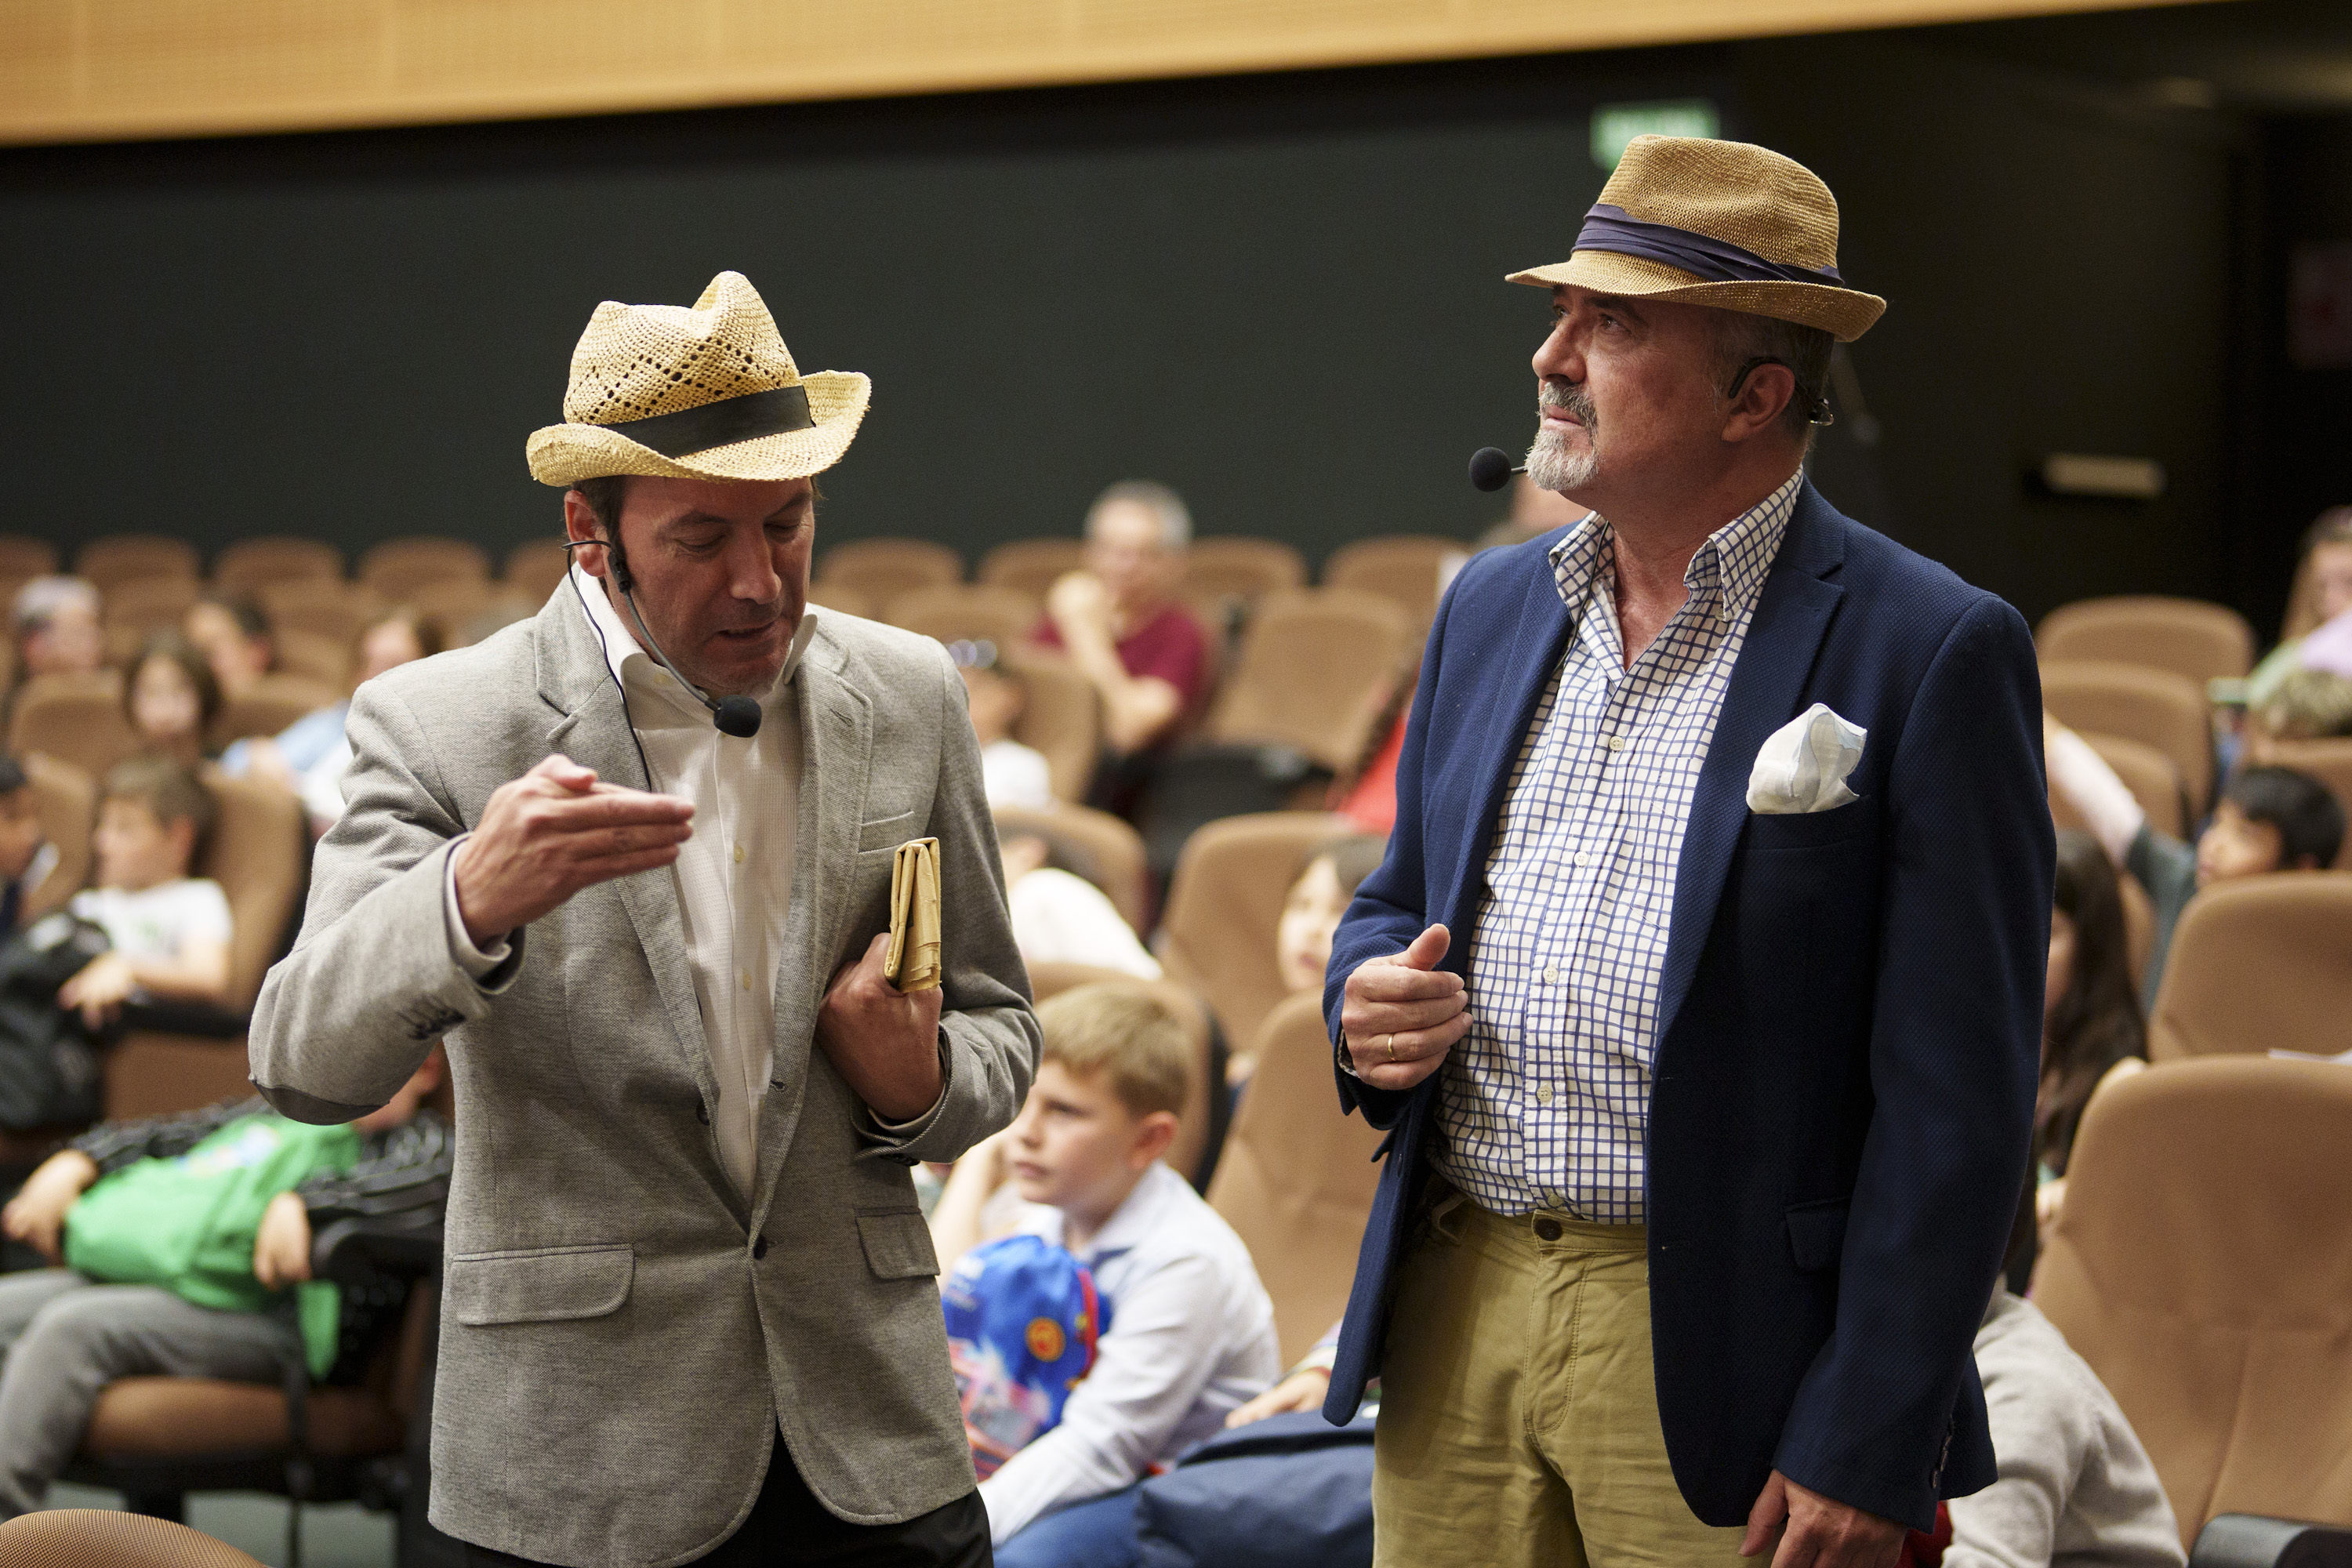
[{"xmin": 0, "ymin": 23, "xmax": 2232, "ymax": 614}]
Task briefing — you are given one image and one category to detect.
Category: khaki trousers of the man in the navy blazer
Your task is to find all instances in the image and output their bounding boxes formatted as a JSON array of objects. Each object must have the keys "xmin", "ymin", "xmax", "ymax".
[{"xmin": 1371, "ymin": 1180, "xmax": 1766, "ymax": 1568}]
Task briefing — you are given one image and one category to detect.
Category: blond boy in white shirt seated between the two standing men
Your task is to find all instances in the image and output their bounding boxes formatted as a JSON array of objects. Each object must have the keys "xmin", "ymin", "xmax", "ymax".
[{"xmin": 931, "ymin": 982, "xmax": 1282, "ymax": 1568}]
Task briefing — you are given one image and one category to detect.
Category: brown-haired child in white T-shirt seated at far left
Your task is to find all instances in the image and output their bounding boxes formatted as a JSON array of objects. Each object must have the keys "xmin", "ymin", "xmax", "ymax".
[{"xmin": 56, "ymin": 757, "xmax": 230, "ymax": 1029}]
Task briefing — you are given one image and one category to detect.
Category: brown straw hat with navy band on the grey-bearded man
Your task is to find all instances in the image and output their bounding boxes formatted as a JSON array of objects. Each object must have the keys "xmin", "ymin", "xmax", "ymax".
[{"xmin": 1508, "ymin": 136, "xmax": 1886, "ymax": 343}]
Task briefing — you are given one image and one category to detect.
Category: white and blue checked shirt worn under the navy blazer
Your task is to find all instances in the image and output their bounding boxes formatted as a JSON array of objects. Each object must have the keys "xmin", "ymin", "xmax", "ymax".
[{"xmin": 1435, "ymin": 470, "xmax": 1804, "ymax": 1225}]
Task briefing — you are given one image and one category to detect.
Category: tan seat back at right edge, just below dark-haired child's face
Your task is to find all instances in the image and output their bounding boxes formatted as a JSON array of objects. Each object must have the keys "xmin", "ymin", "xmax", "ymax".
[{"xmin": 2147, "ymin": 872, "xmax": 2352, "ymax": 1062}]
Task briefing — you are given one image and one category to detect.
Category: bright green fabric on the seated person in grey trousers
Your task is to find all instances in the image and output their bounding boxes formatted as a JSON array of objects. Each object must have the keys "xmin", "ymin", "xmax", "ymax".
[{"xmin": 66, "ymin": 1112, "xmax": 360, "ymax": 1377}]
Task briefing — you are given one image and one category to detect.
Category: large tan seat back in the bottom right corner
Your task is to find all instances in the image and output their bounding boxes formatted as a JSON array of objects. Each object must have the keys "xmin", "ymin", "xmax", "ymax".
[{"xmin": 2034, "ymin": 1055, "xmax": 2352, "ymax": 1544}]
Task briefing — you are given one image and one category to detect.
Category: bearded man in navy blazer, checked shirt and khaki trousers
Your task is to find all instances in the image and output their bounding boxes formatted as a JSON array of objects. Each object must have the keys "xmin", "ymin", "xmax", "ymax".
[{"xmin": 1327, "ymin": 139, "xmax": 2053, "ymax": 1568}]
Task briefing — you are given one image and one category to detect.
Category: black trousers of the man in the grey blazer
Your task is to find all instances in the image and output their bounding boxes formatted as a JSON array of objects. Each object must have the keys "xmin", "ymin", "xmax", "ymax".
[{"xmin": 466, "ymin": 1439, "xmax": 995, "ymax": 1568}]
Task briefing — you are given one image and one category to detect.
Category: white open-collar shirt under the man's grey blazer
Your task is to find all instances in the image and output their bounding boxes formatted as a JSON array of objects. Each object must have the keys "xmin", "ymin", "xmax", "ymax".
[{"xmin": 445, "ymin": 567, "xmax": 816, "ymax": 1201}]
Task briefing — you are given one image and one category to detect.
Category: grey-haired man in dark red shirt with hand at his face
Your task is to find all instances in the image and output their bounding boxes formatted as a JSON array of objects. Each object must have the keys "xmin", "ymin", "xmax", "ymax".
[{"xmin": 1035, "ymin": 480, "xmax": 1209, "ymax": 811}]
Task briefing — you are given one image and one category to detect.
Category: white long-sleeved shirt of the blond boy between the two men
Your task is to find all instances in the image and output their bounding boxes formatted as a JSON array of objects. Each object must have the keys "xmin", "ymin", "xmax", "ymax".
[{"xmin": 981, "ymin": 1163, "xmax": 1282, "ymax": 1547}]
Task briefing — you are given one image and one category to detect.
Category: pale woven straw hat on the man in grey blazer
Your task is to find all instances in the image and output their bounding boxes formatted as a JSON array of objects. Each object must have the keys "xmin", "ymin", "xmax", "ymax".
[{"xmin": 524, "ymin": 273, "xmax": 873, "ymax": 485}]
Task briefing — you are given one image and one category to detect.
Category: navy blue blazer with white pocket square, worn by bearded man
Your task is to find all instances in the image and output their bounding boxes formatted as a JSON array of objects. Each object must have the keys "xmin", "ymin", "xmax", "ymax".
[{"xmin": 1324, "ymin": 485, "xmax": 2056, "ymax": 1528}]
